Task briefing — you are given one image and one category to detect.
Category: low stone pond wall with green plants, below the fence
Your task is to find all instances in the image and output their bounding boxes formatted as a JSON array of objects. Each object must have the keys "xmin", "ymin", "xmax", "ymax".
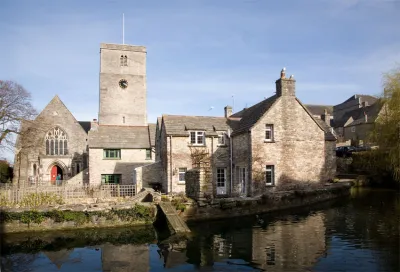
[{"xmin": 0, "ymin": 201, "xmax": 156, "ymax": 233}]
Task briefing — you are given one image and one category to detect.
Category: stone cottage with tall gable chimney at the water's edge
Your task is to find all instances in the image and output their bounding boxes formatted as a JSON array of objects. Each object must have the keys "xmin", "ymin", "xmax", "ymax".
[{"xmin": 156, "ymin": 70, "xmax": 336, "ymax": 196}]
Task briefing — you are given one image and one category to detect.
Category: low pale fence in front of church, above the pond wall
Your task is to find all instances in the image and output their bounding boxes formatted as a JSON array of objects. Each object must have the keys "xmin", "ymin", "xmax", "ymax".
[{"xmin": 0, "ymin": 184, "xmax": 136, "ymax": 203}]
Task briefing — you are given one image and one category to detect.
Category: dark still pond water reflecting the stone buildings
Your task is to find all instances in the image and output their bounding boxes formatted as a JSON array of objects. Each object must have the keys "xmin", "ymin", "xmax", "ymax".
[{"xmin": 1, "ymin": 189, "xmax": 400, "ymax": 272}]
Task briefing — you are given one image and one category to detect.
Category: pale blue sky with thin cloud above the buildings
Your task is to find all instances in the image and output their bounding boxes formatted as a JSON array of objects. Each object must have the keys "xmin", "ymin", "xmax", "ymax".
[{"xmin": 0, "ymin": 0, "xmax": 400, "ymax": 160}]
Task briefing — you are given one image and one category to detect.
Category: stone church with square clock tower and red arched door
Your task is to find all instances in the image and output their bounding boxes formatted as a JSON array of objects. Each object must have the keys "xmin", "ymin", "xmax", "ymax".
[{"xmin": 14, "ymin": 43, "xmax": 155, "ymax": 185}]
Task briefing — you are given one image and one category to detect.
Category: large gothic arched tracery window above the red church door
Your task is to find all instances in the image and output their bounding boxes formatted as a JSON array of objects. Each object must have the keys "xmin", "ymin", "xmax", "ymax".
[{"xmin": 46, "ymin": 127, "xmax": 68, "ymax": 155}]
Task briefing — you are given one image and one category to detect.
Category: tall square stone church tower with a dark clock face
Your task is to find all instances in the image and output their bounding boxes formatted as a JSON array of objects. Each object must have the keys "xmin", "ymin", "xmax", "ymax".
[{"xmin": 99, "ymin": 43, "xmax": 147, "ymax": 126}]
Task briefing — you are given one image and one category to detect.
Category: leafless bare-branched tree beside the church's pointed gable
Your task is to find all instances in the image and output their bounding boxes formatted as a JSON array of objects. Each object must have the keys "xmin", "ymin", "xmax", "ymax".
[{"xmin": 0, "ymin": 80, "xmax": 37, "ymax": 148}]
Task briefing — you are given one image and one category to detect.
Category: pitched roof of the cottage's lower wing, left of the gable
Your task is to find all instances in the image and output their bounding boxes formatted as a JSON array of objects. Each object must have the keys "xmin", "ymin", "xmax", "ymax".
[{"xmin": 162, "ymin": 115, "xmax": 229, "ymax": 136}]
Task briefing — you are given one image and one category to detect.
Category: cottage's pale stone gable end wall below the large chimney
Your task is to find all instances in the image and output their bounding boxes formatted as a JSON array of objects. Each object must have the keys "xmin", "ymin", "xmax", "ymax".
[{"xmin": 251, "ymin": 96, "xmax": 332, "ymax": 185}]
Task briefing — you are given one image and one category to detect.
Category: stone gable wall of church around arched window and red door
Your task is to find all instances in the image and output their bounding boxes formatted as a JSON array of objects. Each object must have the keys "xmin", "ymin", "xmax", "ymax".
[{"xmin": 14, "ymin": 96, "xmax": 88, "ymax": 188}]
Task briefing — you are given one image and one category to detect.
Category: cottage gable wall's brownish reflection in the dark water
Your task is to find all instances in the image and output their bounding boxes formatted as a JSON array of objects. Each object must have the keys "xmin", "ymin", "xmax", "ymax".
[{"xmin": 252, "ymin": 213, "xmax": 326, "ymax": 271}]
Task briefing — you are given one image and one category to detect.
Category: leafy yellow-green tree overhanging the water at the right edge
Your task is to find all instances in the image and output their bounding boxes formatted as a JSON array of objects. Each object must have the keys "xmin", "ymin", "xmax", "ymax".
[{"xmin": 372, "ymin": 67, "xmax": 400, "ymax": 181}]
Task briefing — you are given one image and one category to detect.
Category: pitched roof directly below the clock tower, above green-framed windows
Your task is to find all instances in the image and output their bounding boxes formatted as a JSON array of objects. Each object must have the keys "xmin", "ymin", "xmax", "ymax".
[{"xmin": 89, "ymin": 125, "xmax": 150, "ymax": 148}]
